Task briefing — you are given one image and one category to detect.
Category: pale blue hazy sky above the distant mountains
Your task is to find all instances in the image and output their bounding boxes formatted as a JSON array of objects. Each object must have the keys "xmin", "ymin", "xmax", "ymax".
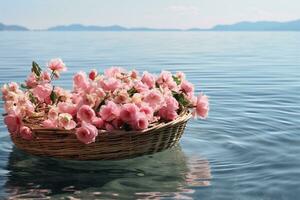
[{"xmin": 0, "ymin": 0, "xmax": 300, "ymax": 29}]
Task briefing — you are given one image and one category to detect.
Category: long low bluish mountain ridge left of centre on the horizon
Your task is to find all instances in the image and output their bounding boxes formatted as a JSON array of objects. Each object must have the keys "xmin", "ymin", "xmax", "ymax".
[{"xmin": 47, "ymin": 24, "xmax": 181, "ymax": 31}]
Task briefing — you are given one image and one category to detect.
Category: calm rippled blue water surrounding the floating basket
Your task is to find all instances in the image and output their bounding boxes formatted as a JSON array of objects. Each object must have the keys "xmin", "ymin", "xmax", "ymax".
[{"xmin": 0, "ymin": 32, "xmax": 300, "ymax": 199}]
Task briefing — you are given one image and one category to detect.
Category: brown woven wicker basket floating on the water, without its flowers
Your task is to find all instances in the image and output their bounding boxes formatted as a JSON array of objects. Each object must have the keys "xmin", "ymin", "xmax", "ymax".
[{"xmin": 11, "ymin": 112, "xmax": 191, "ymax": 160}]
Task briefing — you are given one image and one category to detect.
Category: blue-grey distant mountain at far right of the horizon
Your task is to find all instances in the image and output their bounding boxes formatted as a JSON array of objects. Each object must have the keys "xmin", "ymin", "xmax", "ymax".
[{"xmin": 210, "ymin": 20, "xmax": 300, "ymax": 31}]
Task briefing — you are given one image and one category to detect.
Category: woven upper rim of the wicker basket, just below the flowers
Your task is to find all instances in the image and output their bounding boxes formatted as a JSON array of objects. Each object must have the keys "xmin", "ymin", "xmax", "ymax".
[{"xmin": 26, "ymin": 110, "xmax": 192, "ymax": 135}]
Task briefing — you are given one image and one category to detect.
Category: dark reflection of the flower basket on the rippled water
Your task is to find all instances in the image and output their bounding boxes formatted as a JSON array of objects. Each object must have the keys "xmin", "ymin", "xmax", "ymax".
[{"xmin": 5, "ymin": 146, "xmax": 211, "ymax": 199}]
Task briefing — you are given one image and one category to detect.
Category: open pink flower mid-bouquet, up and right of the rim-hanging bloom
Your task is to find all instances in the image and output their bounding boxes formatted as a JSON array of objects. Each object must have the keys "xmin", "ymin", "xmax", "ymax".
[{"xmin": 99, "ymin": 101, "xmax": 120, "ymax": 121}]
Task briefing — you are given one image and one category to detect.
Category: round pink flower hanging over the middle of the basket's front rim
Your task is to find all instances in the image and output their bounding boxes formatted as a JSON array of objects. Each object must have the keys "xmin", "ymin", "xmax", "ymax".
[{"xmin": 75, "ymin": 122, "xmax": 98, "ymax": 144}]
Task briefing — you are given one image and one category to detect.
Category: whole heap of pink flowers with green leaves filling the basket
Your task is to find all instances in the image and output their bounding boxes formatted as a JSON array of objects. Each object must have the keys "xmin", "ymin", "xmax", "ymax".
[{"xmin": 2, "ymin": 59, "xmax": 209, "ymax": 144}]
